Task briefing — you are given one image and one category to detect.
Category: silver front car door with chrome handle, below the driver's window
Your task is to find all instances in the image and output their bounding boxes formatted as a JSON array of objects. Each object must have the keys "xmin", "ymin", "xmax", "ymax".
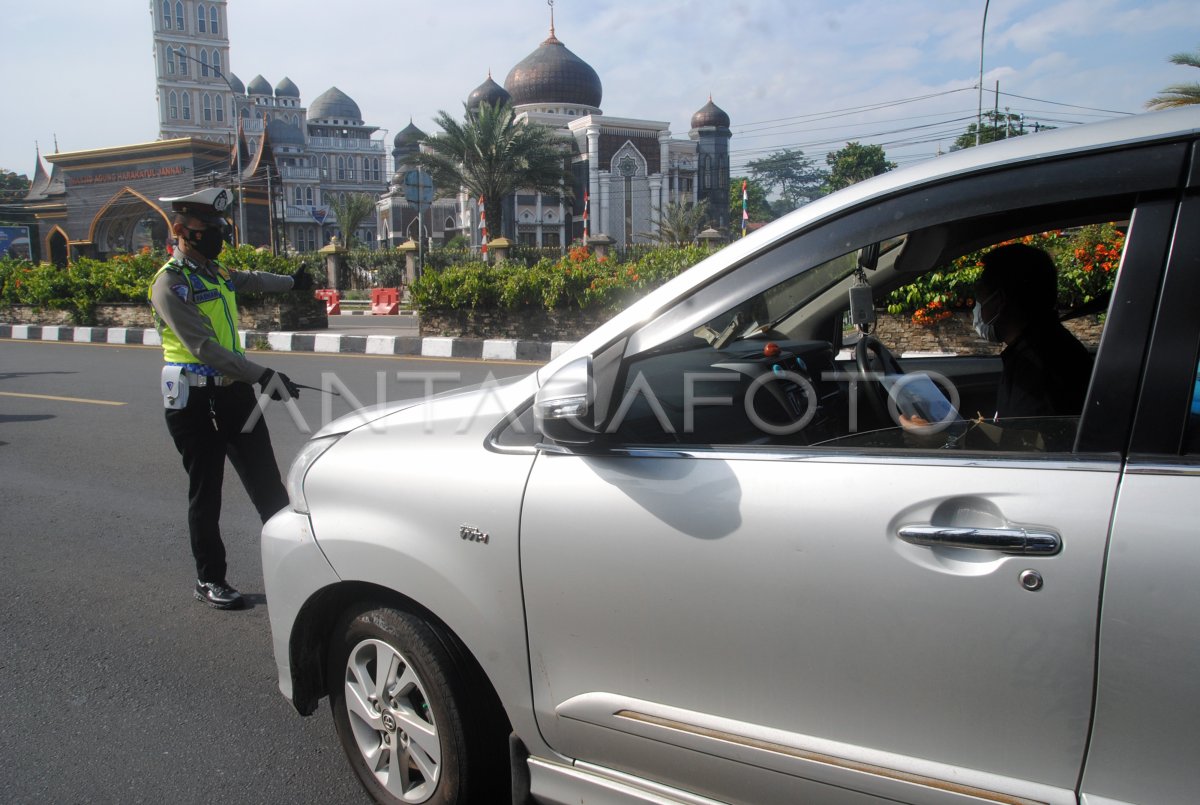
[{"xmin": 521, "ymin": 154, "xmax": 1177, "ymax": 803}]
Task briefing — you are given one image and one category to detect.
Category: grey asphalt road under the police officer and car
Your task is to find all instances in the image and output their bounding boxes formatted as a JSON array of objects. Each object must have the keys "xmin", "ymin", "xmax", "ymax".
[{"xmin": 0, "ymin": 340, "xmax": 534, "ymax": 805}]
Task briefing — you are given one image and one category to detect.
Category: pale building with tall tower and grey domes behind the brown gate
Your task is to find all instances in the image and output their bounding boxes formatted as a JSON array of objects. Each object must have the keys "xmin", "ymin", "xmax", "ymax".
[{"xmin": 150, "ymin": 0, "xmax": 389, "ymax": 251}]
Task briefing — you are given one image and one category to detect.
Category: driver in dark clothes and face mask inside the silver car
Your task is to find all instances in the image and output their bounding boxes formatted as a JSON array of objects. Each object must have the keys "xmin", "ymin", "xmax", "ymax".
[{"xmin": 974, "ymin": 244, "xmax": 1092, "ymax": 419}]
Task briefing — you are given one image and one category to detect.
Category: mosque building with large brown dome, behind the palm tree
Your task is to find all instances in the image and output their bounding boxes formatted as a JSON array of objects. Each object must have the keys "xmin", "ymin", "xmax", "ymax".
[{"xmin": 378, "ymin": 7, "xmax": 731, "ymax": 247}]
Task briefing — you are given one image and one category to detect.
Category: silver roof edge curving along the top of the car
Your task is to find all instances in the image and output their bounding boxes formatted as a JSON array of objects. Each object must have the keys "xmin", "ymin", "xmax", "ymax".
[{"xmin": 539, "ymin": 107, "xmax": 1200, "ymax": 378}]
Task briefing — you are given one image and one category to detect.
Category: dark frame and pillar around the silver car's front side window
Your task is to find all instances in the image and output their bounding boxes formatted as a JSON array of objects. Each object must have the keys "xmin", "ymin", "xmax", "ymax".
[{"xmin": 596, "ymin": 142, "xmax": 1187, "ymax": 459}]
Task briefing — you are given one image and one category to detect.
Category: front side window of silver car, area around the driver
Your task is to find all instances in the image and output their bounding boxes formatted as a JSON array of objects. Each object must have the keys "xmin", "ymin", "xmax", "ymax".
[{"xmin": 607, "ymin": 216, "xmax": 1127, "ymax": 455}]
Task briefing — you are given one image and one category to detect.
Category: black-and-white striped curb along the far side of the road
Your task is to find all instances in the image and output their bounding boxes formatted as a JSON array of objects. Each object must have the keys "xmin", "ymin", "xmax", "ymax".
[{"xmin": 0, "ymin": 324, "xmax": 574, "ymax": 362}]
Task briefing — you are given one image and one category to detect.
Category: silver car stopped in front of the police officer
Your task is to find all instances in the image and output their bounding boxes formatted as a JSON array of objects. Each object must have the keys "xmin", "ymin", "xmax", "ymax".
[{"xmin": 263, "ymin": 108, "xmax": 1200, "ymax": 805}]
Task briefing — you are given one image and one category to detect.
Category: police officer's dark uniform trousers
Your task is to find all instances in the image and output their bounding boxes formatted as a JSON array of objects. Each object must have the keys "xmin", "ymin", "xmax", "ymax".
[{"xmin": 167, "ymin": 383, "xmax": 288, "ymax": 582}]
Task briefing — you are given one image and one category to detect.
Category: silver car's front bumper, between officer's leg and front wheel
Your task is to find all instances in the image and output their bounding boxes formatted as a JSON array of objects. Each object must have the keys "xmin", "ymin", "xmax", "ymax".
[{"xmin": 262, "ymin": 509, "xmax": 338, "ymax": 702}]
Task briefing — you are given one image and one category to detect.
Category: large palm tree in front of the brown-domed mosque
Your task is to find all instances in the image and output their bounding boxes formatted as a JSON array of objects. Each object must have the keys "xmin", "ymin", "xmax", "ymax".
[{"xmin": 412, "ymin": 102, "xmax": 572, "ymax": 245}]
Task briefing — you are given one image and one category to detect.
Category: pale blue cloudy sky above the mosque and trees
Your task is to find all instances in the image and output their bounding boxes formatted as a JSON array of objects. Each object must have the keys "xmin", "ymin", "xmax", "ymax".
[{"xmin": 0, "ymin": 0, "xmax": 1200, "ymax": 182}]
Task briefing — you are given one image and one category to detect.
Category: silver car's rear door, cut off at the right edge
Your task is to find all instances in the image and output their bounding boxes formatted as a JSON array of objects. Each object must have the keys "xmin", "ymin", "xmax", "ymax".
[{"xmin": 1081, "ymin": 187, "xmax": 1200, "ymax": 805}]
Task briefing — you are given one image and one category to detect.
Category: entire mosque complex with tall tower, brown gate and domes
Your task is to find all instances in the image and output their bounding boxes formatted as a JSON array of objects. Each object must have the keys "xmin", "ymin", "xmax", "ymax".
[{"xmin": 9, "ymin": 0, "xmax": 731, "ymax": 264}]
